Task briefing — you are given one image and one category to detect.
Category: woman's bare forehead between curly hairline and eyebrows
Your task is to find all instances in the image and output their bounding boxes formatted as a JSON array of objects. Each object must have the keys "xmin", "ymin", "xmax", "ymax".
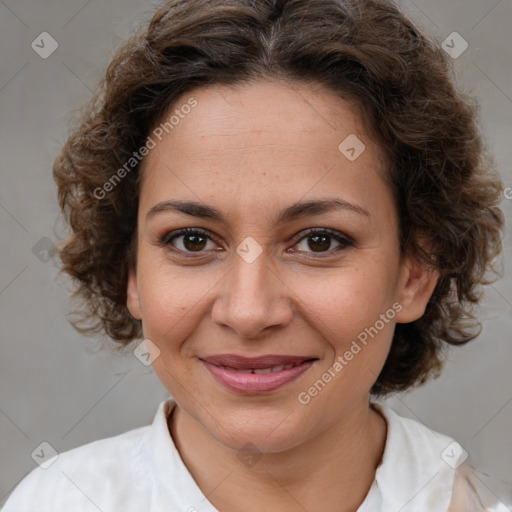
[{"xmin": 141, "ymin": 81, "xmax": 390, "ymax": 224}]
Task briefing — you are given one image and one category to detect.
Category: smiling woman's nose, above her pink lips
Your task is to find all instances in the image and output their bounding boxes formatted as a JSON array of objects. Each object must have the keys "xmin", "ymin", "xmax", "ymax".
[{"xmin": 212, "ymin": 252, "xmax": 293, "ymax": 339}]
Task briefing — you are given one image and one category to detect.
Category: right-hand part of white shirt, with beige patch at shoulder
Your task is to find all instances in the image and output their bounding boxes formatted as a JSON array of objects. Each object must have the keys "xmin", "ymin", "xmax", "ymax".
[{"xmin": 373, "ymin": 404, "xmax": 512, "ymax": 512}]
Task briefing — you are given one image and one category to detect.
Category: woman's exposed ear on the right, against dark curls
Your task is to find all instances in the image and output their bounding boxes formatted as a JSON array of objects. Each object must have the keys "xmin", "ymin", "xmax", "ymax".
[{"xmin": 396, "ymin": 253, "xmax": 439, "ymax": 323}]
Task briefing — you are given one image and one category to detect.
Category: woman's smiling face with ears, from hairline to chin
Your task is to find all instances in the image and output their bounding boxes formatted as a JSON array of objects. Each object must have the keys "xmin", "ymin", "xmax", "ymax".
[{"xmin": 128, "ymin": 81, "xmax": 435, "ymax": 452}]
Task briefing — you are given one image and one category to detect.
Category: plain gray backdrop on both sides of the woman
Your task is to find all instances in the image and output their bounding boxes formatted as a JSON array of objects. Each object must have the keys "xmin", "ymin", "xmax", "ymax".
[{"xmin": 0, "ymin": 0, "xmax": 512, "ymax": 506}]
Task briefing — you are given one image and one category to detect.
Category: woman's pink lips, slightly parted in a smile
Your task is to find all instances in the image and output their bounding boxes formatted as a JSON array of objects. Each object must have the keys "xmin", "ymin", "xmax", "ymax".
[{"xmin": 200, "ymin": 354, "xmax": 316, "ymax": 395}]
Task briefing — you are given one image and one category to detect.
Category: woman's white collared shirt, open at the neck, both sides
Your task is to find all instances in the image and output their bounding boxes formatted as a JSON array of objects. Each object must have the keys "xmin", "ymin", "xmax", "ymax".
[{"xmin": 2, "ymin": 398, "xmax": 512, "ymax": 512}]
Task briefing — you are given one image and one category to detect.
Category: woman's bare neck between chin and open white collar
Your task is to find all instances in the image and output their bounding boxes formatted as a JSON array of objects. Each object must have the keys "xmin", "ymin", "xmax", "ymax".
[{"xmin": 169, "ymin": 400, "xmax": 386, "ymax": 512}]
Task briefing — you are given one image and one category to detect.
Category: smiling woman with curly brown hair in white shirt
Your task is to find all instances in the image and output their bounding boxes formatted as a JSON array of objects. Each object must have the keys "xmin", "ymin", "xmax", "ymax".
[{"xmin": 4, "ymin": 0, "xmax": 507, "ymax": 512}]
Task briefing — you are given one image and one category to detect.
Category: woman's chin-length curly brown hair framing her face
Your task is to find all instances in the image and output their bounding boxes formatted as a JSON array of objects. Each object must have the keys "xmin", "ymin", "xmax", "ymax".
[{"xmin": 53, "ymin": 0, "xmax": 503, "ymax": 395}]
